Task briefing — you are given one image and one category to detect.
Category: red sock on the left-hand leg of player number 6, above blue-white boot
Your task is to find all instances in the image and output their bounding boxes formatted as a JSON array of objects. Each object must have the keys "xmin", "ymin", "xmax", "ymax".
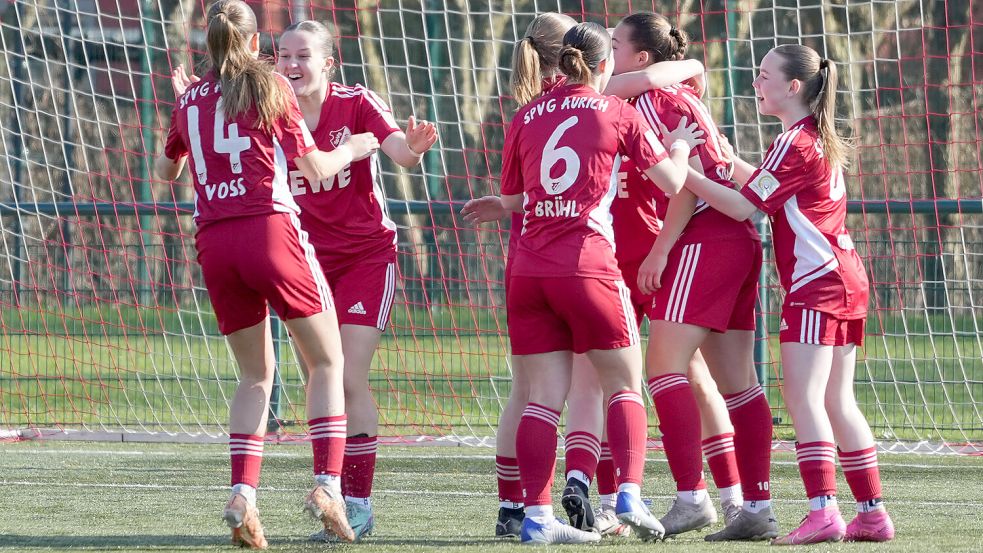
[{"xmin": 515, "ymin": 403, "xmax": 560, "ymax": 507}]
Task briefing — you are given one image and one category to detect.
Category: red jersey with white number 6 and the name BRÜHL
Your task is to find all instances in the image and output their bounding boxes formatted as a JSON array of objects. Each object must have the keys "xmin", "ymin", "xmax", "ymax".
[{"xmin": 502, "ymin": 85, "xmax": 666, "ymax": 278}]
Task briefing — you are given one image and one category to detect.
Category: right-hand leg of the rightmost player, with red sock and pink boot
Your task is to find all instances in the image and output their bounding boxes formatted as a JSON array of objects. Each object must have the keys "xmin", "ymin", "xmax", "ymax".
[{"xmin": 826, "ymin": 328, "xmax": 894, "ymax": 541}]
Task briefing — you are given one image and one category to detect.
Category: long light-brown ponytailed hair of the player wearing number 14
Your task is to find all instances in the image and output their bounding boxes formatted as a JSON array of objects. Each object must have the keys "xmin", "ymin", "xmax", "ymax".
[{"xmin": 206, "ymin": 0, "xmax": 289, "ymax": 132}]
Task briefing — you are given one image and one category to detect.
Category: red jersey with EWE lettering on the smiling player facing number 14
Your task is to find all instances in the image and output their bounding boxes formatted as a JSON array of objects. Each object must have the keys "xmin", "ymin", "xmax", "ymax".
[{"xmin": 289, "ymin": 83, "xmax": 400, "ymax": 270}]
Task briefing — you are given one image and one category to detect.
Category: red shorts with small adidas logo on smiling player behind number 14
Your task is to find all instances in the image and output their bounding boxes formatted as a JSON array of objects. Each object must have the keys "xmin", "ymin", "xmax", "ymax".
[{"xmin": 324, "ymin": 261, "xmax": 396, "ymax": 330}]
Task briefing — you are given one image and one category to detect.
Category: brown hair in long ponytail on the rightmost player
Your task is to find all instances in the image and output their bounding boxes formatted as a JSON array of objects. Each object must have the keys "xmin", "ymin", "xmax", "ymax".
[{"xmin": 774, "ymin": 44, "xmax": 852, "ymax": 168}]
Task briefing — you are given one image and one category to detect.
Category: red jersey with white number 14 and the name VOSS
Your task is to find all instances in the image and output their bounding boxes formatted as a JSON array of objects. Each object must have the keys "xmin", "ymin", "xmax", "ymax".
[{"xmin": 164, "ymin": 73, "xmax": 315, "ymax": 229}]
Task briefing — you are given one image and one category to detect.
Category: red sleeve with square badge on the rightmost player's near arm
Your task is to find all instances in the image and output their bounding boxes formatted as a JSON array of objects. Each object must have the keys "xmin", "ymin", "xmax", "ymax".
[{"xmin": 741, "ymin": 130, "xmax": 814, "ymax": 215}]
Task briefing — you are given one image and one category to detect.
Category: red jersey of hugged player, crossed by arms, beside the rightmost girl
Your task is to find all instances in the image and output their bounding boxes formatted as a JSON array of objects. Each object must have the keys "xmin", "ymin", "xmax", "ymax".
[{"xmin": 635, "ymin": 84, "xmax": 760, "ymax": 243}]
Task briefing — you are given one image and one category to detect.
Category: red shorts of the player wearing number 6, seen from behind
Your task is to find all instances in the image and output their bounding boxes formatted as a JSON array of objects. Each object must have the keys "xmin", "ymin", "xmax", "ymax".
[{"xmin": 506, "ymin": 276, "xmax": 638, "ymax": 355}]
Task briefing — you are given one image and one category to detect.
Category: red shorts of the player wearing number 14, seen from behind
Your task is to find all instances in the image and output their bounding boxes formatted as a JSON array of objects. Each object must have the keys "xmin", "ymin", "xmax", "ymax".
[{"xmin": 195, "ymin": 213, "xmax": 334, "ymax": 334}]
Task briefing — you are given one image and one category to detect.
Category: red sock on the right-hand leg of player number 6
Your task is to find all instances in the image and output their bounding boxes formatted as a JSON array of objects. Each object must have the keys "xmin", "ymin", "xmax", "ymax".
[{"xmin": 607, "ymin": 390, "xmax": 648, "ymax": 484}]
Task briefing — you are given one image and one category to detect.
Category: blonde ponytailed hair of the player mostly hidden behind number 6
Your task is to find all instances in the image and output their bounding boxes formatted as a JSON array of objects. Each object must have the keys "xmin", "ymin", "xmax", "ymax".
[{"xmin": 509, "ymin": 12, "xmax": 577, "ymax": 106}]
